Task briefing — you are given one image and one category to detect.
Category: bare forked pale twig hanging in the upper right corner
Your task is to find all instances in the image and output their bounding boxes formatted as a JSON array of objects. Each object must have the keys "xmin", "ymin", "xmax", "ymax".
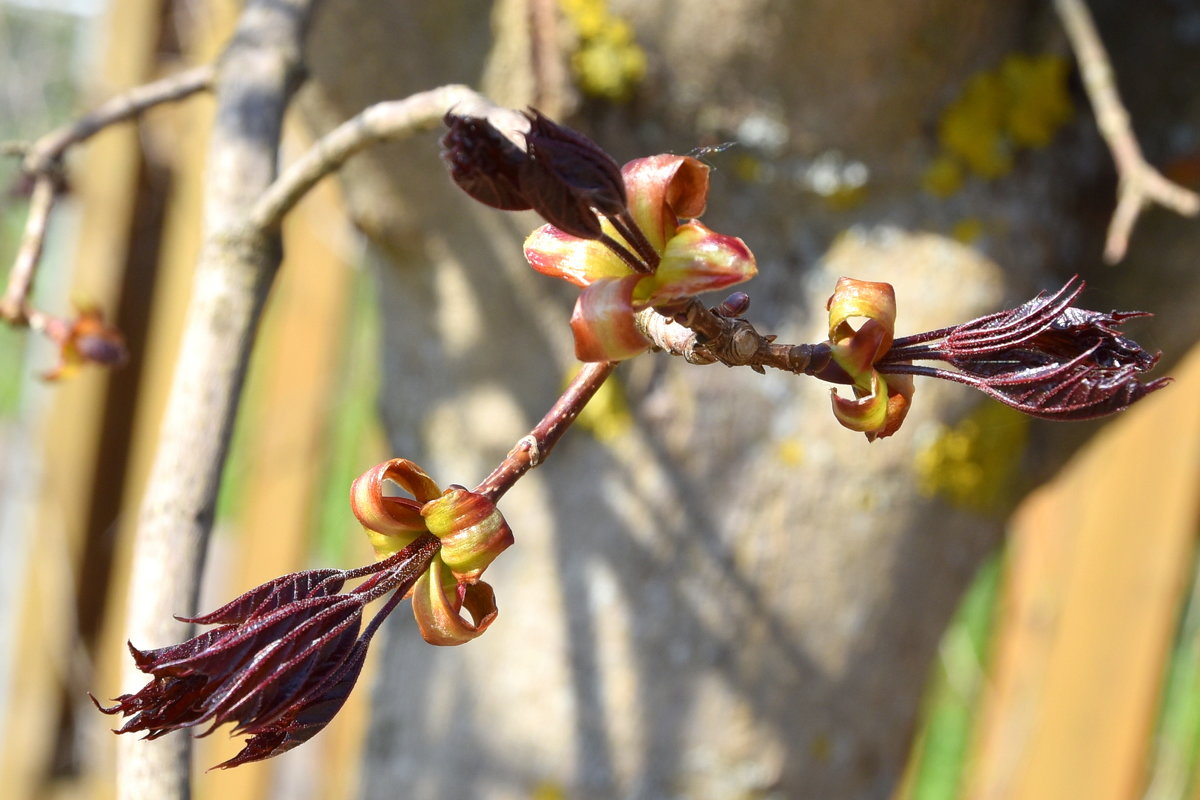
[{"xmin": 1055, "ymin": 0, "xmax": 1200, "ymax": 264}]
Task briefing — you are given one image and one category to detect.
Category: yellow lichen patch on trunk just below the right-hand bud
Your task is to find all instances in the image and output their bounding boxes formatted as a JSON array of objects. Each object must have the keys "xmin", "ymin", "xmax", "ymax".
[{"xmin": 916, "ymin": 402, "xmax": 1028, "ymax": 511}]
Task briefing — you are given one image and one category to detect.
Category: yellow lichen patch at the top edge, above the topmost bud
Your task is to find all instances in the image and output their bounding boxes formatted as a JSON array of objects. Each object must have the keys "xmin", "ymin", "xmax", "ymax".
[{"xmin": 559, "ymin": 0, "xmax": 646, "ymax": 101}]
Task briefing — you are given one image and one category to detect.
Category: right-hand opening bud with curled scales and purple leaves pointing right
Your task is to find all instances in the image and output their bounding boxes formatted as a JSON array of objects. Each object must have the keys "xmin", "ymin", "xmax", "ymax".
[{"xmin": 814, "ymin": 276, "xmax": 1171, "ymax": 439}]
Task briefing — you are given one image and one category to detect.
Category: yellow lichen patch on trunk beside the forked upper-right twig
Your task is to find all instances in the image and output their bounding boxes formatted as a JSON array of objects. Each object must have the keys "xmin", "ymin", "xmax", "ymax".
[{"xmin": 924, "ymin": 53, "xmax": 1074, "ymax": 197}]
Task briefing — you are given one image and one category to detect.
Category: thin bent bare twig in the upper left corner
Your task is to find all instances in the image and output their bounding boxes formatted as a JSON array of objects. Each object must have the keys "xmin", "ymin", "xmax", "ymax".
[{"xmin": 0, "ymin": 66, "xmax": 214, "ymax": 329}]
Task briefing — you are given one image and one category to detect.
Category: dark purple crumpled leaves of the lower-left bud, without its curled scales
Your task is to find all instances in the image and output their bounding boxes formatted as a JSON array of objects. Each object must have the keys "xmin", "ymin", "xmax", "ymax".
[{"xmin": 92, "ymin": 534, "xmax": 442, "ymax": 769}]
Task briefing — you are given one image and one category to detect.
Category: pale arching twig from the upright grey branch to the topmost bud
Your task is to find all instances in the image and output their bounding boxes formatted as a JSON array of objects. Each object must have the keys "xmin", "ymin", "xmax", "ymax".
[{"xmin": 248, "ymin": 85, "xmax": 494, "ymax": 230}]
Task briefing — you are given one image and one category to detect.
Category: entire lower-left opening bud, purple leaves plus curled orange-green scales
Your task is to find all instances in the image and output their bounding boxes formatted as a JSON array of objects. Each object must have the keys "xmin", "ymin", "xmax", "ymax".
[{"xmin": 104, "ymin": 448, "xmax": 525, "ymax": 768}]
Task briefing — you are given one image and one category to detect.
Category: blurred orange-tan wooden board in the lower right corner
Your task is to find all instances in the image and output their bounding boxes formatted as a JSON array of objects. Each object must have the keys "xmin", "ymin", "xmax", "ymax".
[{"xmin": 967, "ymin": 349, "xmax": 1200, "ymax": 800}]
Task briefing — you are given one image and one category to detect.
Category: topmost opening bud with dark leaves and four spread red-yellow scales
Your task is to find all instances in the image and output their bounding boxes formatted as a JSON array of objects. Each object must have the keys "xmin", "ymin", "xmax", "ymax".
[{"xmin": 443, "ymin": 110, "xmax": 757, "ymax": 361}]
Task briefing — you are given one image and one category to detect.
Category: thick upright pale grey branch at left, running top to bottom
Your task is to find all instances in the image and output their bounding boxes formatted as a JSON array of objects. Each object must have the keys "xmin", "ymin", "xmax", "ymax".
[{"xmin": 118, "ymin": 0, "xmax": 313, "ymax": 800}]
